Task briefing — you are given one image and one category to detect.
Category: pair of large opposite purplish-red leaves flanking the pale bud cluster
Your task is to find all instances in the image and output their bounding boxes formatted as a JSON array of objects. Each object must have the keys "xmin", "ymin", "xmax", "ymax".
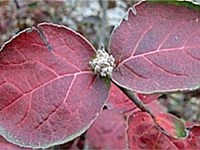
[{"xmin": 0, "ymin": 2, "xmax": 200, "ymax": 148}]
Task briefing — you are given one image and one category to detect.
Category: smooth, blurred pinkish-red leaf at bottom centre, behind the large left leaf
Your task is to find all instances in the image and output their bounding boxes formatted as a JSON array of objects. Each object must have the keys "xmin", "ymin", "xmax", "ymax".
[{"xmin": 86, "ymin": 110, "xmax": 127, "ymax": 149}]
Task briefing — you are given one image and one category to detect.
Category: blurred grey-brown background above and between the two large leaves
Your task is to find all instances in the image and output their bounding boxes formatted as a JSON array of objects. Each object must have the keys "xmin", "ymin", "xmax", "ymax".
[{"xmin": 0, "ymin": 0, "xmax": 138, "ymax": 48}]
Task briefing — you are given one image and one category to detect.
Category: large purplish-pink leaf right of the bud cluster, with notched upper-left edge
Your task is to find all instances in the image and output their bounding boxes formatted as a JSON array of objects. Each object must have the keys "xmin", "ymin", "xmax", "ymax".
[{"xmin": 109, "ymin": 2, "xmax": 200, "ymax": 93}]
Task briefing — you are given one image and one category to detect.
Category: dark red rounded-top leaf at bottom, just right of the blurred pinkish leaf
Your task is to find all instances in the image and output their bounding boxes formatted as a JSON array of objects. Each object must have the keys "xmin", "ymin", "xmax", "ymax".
[{"xmin": 128, "ymin": 112, "xmax": 177, "ymax": 149}]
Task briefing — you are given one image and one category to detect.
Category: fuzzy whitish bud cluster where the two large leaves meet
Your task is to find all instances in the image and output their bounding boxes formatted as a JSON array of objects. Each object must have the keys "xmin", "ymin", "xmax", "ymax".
[{"xmin": 89, "ymin": 49, "xmax": 115, "ymax": 77}]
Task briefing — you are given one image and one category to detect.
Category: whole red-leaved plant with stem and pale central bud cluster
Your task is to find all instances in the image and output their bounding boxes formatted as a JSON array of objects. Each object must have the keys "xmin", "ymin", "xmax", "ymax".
[{"xmin": 0, "ymin": 1, "xmax": 200, "ymax": 149}]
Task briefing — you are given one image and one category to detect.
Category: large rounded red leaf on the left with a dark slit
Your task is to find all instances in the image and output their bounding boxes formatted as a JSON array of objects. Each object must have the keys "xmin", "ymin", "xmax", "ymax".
[{"xmin": 0, "ymin": 23, "xmax": 108, "ymax": 148}]
